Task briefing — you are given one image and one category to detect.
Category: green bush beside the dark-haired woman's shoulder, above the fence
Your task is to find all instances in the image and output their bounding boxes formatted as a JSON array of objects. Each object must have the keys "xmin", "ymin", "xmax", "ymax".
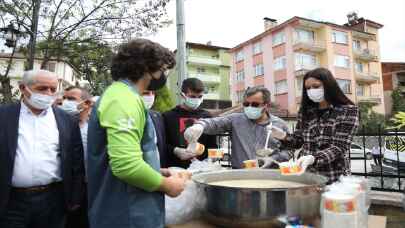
[{"xmin": 358, "ymin": 102, "xmax": 386, "ymax": 133}]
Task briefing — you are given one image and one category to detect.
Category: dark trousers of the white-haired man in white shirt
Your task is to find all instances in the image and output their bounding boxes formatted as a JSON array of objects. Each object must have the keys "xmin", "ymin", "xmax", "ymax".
[{"xmin": 0, "ymin": 185, "xmax": 66, "ymax": 228}]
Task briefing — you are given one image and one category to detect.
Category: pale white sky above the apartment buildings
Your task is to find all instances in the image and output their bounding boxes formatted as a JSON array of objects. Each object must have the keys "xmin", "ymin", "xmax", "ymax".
[{"xmin": 146, "ymin": 0, "xmax": 405, "ymax": 62}]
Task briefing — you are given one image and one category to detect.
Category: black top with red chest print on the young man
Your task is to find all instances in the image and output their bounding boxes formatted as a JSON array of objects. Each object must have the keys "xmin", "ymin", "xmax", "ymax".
[{"xmin": 163, "ymin": 106, "xmax": 217, "ymax": 168}]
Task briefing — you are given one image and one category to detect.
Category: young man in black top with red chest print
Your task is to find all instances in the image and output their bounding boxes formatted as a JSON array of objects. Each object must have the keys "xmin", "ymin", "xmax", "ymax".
[{"xmin": 163, "ymin": 78, "xmax": 217, "ymax": 168}]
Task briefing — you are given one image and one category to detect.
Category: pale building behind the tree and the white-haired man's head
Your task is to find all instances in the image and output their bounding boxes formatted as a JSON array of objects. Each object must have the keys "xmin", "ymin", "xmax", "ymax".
[{"xmin": 0, "ymin": 53, "xmax": 79, "ymax": 91}]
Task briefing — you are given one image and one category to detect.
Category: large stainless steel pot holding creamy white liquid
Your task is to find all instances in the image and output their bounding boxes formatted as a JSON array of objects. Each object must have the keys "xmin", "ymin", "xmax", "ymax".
[{"xmin": 193, "ymin": 169, "xmax": 327, "ymax": 227}]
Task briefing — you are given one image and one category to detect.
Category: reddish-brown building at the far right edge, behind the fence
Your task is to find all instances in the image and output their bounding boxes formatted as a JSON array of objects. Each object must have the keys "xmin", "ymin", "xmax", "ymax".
[{"xmin": 381, "ymin": 62, "xmax": 405, "ymax": 116}]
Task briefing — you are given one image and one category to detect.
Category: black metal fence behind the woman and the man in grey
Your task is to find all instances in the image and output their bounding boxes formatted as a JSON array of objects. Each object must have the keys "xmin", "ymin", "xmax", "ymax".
[{"xmin": 216, "ymin": 127, "xmax": 405, "ymax": 192}]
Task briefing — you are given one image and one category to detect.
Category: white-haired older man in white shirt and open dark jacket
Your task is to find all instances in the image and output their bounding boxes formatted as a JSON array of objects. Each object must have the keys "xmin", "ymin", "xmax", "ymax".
[{"xmin": 0, "ymin": 70, "xmax": 84, "ymax": 228}]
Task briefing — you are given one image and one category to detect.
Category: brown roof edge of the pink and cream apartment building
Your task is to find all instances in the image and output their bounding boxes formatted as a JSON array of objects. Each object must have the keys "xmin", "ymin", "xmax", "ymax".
[{"xmin": 229, "ymin": 16, "xmax": 382, "ymax": 52}]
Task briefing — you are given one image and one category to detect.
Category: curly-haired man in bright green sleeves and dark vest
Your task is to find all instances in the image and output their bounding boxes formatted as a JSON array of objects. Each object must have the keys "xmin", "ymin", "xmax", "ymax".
[{"xmin": 87, "ymin": 39, "xmax": 186, "ymax": 228}]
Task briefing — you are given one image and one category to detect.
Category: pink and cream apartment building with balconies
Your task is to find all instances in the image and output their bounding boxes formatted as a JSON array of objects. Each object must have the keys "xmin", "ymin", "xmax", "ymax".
[{"xmin": 230, "ymin": 16, "xmax": 385, "ymax": 114}]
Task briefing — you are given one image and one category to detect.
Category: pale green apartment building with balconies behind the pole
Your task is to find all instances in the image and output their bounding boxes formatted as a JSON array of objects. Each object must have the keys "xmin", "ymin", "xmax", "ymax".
[{"xmin": 168, "ymin": 42, "xmax": 232, "ymax": 109}]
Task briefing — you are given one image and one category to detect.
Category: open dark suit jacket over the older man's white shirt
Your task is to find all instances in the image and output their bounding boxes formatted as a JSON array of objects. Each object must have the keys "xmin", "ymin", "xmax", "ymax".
[{"xmin": 0, "ymin": 104, "xmax": 84, "ymax": 217}]
